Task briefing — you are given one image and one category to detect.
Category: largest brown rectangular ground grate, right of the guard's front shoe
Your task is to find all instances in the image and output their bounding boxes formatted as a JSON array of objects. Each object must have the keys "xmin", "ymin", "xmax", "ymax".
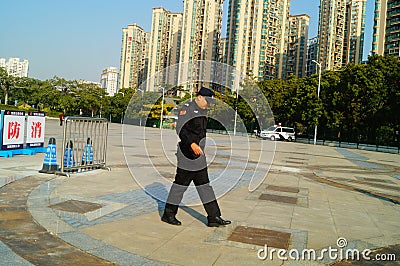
[{"xmin": 228, "ymin": 226, "xmax": 291, "ymax": 250}]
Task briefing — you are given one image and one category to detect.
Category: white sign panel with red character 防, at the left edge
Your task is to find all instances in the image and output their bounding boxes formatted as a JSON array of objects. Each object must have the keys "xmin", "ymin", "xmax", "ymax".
[{"xmin": 1, "ymin": 111, "xmax": 25, "ymax": 150}]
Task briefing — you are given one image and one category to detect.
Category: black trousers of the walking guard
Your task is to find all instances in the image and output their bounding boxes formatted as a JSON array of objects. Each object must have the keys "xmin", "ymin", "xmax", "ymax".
[{"xmin": 164, "ymin": 167, "xmax": 221, "ymax": 217}]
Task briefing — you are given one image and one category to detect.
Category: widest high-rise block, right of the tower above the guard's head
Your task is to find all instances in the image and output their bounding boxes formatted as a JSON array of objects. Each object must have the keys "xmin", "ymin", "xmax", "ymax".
[{"xmin": 226, "ymin": 0, "xmax": 290, "ymax": 80}]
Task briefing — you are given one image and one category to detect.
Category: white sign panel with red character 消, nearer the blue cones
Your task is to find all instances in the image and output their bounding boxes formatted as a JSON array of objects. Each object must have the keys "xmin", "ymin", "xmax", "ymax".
[{"xmin": 26, "ymin": 112, "xmax": 46, "ymax": 148}]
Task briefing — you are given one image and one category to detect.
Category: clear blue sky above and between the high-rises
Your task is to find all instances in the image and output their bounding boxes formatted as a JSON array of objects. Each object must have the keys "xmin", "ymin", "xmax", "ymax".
[{"xmin": 0, "ymin": 0, "xmax": 374, "ymax": 82}]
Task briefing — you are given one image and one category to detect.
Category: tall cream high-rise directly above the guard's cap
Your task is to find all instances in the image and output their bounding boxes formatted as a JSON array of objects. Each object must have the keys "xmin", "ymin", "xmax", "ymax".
[{"xmin": 180, "ymin": 0, "xmax": 224, "ymax": 91}]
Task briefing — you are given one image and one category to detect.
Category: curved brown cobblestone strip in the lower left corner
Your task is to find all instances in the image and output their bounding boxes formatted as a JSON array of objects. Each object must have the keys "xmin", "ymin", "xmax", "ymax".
[{"xmin": 0, "ymin": 176, "xmax": 113, "ymax": 265}]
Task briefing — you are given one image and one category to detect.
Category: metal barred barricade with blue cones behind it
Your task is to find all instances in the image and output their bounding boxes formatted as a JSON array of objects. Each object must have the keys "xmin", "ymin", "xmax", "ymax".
[{"xmin": 58, "ymin": 117, "xmax": 110, "ymax": 176}]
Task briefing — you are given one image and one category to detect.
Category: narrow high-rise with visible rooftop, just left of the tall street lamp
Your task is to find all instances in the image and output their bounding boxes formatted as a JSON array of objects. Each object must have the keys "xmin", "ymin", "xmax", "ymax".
[{"xmin": 284, "ymin": 14, "xmax": 310, "ymax": 78}]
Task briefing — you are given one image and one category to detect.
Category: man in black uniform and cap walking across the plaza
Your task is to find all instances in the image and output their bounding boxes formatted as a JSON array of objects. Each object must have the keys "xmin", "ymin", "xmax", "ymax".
[{"xmin": 161, "ymin": 87, "xmax": 231, "ymax": 227}]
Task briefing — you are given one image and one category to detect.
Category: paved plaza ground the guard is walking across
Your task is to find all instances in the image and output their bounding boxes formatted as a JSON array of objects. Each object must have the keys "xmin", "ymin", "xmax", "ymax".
[{"xmin": 0, "ymin": 119, "xmax": 400, "ymax": 265}]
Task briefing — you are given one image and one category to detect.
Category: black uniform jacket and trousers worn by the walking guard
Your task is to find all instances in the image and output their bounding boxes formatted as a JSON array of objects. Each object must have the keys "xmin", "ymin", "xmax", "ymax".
[{"xmin": 165, "ymin": 101, "xmax": 221, "ymax": 217}]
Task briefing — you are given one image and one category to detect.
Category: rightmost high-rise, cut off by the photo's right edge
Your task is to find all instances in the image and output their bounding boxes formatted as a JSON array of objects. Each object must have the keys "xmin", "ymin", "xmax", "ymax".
[{"xmin": 372, "ymin": 0, "xmax": 400, "ymax": 57}]
